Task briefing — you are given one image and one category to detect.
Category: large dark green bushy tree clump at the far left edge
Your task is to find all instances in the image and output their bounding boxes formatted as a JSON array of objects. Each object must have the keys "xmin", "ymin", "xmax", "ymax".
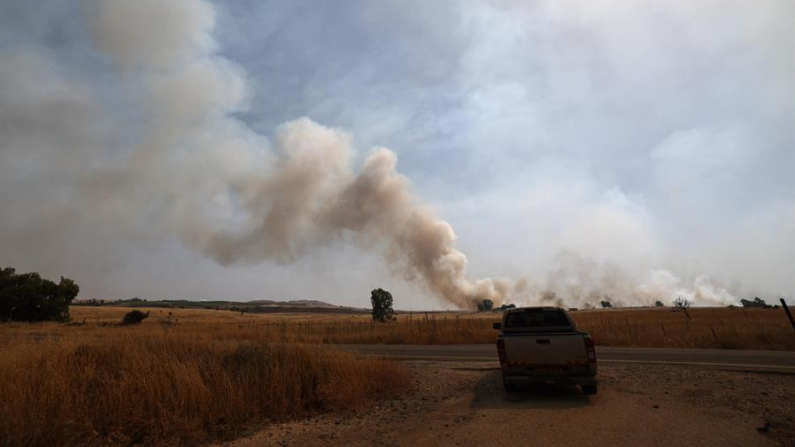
[{"xmin": 0, "ymin": 267, "xmax": 80, "ymax": 322}]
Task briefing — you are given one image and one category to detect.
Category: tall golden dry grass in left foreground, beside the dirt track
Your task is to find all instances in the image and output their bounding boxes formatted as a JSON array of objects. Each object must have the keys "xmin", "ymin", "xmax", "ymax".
[{"xmin": 0, "ymin": 324, "xmax": 409, "ymax": 446}]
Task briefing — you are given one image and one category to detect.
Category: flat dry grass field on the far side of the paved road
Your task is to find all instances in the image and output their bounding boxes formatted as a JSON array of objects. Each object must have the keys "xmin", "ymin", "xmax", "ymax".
[{"xmin": 60, "ymin": 307, "xmax": 795, "ymax": 350}]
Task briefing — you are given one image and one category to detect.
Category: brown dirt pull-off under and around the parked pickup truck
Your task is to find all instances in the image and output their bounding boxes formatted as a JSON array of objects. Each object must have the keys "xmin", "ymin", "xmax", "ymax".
[{"xmin": 225, "ymin": 362, "xmax": 795, "ymax": 447}]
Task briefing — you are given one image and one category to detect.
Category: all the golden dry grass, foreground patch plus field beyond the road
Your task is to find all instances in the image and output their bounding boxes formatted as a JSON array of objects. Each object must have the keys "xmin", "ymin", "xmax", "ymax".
[{"xmin": 0, "ymin": 307, "xmax": 795, "ymax": 446}]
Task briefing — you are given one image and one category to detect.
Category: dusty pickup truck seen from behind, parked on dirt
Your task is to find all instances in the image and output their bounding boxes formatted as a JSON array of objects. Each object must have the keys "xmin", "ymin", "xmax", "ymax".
[{"xmin": 494, "ymin": 307, "xmax": 597, "ymax": 394}]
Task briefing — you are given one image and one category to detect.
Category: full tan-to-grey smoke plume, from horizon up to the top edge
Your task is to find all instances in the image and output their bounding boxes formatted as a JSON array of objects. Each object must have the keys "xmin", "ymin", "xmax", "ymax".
[{"xmin": 82, "ymin": 0, "xmax": 509, "ymax": 308}]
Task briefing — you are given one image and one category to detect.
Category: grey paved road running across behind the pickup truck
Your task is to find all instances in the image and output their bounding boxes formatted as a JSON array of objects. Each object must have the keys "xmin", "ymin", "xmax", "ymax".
[{"xmin": 340, "ymin": 344, "xmax": 795, "ymax": 374}]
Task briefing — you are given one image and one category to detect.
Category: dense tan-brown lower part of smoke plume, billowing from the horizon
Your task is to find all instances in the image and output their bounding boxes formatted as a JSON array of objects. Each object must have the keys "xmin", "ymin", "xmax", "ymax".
[{"xmin": 197, "ymin": 122, "xmax": 509, "ymax": 308}]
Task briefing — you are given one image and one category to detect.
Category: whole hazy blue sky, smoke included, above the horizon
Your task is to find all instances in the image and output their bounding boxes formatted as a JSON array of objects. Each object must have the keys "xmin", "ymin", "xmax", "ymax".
[{"xmin": 0, "ymin": 0, "xmax": 795, "ymax": 309}]
